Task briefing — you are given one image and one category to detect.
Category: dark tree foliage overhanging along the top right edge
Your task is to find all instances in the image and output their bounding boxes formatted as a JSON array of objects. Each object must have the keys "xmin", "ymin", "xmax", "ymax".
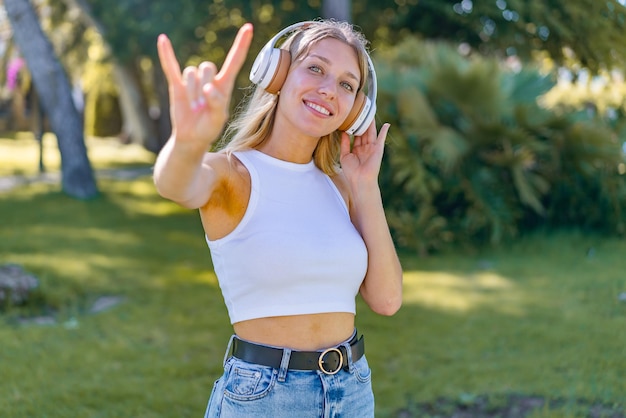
[{"xmin": 354, "ymin": 0, "xmax": 626, "ymax": 72}]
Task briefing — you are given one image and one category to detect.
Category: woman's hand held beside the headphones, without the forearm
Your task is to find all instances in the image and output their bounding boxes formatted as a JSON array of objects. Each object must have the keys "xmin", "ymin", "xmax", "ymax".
[{"xmin": 340, "ymin": 121, "xmax": 390, "ymax": 185}]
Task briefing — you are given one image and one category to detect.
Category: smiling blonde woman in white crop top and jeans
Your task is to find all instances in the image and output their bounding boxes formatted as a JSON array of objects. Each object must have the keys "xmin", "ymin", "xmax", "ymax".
[{"xmin": 154, "ymin": 20, "xmax": 402, "ymax": 418}]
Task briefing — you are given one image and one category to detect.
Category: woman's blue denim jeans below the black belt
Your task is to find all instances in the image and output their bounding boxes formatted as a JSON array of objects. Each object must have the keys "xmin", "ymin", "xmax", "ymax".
[{"xmin": 204, "ymin": 338, "xmax": 374, "ymax": 418}]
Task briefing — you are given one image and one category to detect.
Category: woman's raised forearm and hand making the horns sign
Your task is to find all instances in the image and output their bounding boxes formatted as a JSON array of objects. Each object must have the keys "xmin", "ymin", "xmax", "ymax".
[{"xmin": 154, "ymin": 24, "xmax": 252, "ymax": 208}]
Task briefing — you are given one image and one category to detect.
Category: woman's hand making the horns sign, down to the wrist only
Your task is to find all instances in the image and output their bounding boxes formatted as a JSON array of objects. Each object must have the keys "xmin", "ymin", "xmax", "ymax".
[{"xmin": 157, "ymin": 23, "xmax": 253, "ymax": 151}]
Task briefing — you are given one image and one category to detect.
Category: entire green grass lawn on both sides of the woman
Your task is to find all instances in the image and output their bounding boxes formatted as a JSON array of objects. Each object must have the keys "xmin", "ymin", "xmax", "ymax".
[{"xmin": 0, "ymin": 139, "xmax": 626, "ymax": 418}]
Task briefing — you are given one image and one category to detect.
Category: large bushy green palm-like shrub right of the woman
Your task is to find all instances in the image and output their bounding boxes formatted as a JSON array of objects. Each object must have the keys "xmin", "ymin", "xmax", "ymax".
[{"xmin": 376, "ymin": 38, "xmax": 626, "ymax": 254}]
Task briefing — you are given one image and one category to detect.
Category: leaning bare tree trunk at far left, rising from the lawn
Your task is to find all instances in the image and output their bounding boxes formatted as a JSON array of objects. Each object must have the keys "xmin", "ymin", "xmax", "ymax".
[{"xmin": 4, "ymin": 0, "xmax": 98, "ymax": 199}]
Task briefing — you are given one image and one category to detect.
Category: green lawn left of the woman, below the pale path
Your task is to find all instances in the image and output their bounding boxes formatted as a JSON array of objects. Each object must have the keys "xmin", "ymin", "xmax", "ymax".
[{"xmin": 0, "ymin": 172, "xmax": 229, "ymax": 417}]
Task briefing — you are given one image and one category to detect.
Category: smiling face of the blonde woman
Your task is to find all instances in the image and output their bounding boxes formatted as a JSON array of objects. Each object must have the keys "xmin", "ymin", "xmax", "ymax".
[{"xmin": 276, "ymin": 38, "xmax": 361, "ymax": 138}]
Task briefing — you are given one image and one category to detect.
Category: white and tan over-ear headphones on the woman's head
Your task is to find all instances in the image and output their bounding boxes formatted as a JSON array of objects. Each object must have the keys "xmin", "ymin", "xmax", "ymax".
[{"xmin": 250, "ymin": 21, "xmax": 377, "ymax": 136}]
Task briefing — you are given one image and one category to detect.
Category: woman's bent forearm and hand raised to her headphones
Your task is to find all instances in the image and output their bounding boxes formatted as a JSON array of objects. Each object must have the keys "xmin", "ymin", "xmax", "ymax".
[{"xmin": 341, "ymin": 122, "xmax": 402, "ymax": 315}]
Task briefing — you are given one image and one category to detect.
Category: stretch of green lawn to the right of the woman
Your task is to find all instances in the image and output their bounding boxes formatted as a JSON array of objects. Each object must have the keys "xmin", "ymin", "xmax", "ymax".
[{"xmin": 367, "ymin": 233, "xmax": 626, "ymax": 417}]
